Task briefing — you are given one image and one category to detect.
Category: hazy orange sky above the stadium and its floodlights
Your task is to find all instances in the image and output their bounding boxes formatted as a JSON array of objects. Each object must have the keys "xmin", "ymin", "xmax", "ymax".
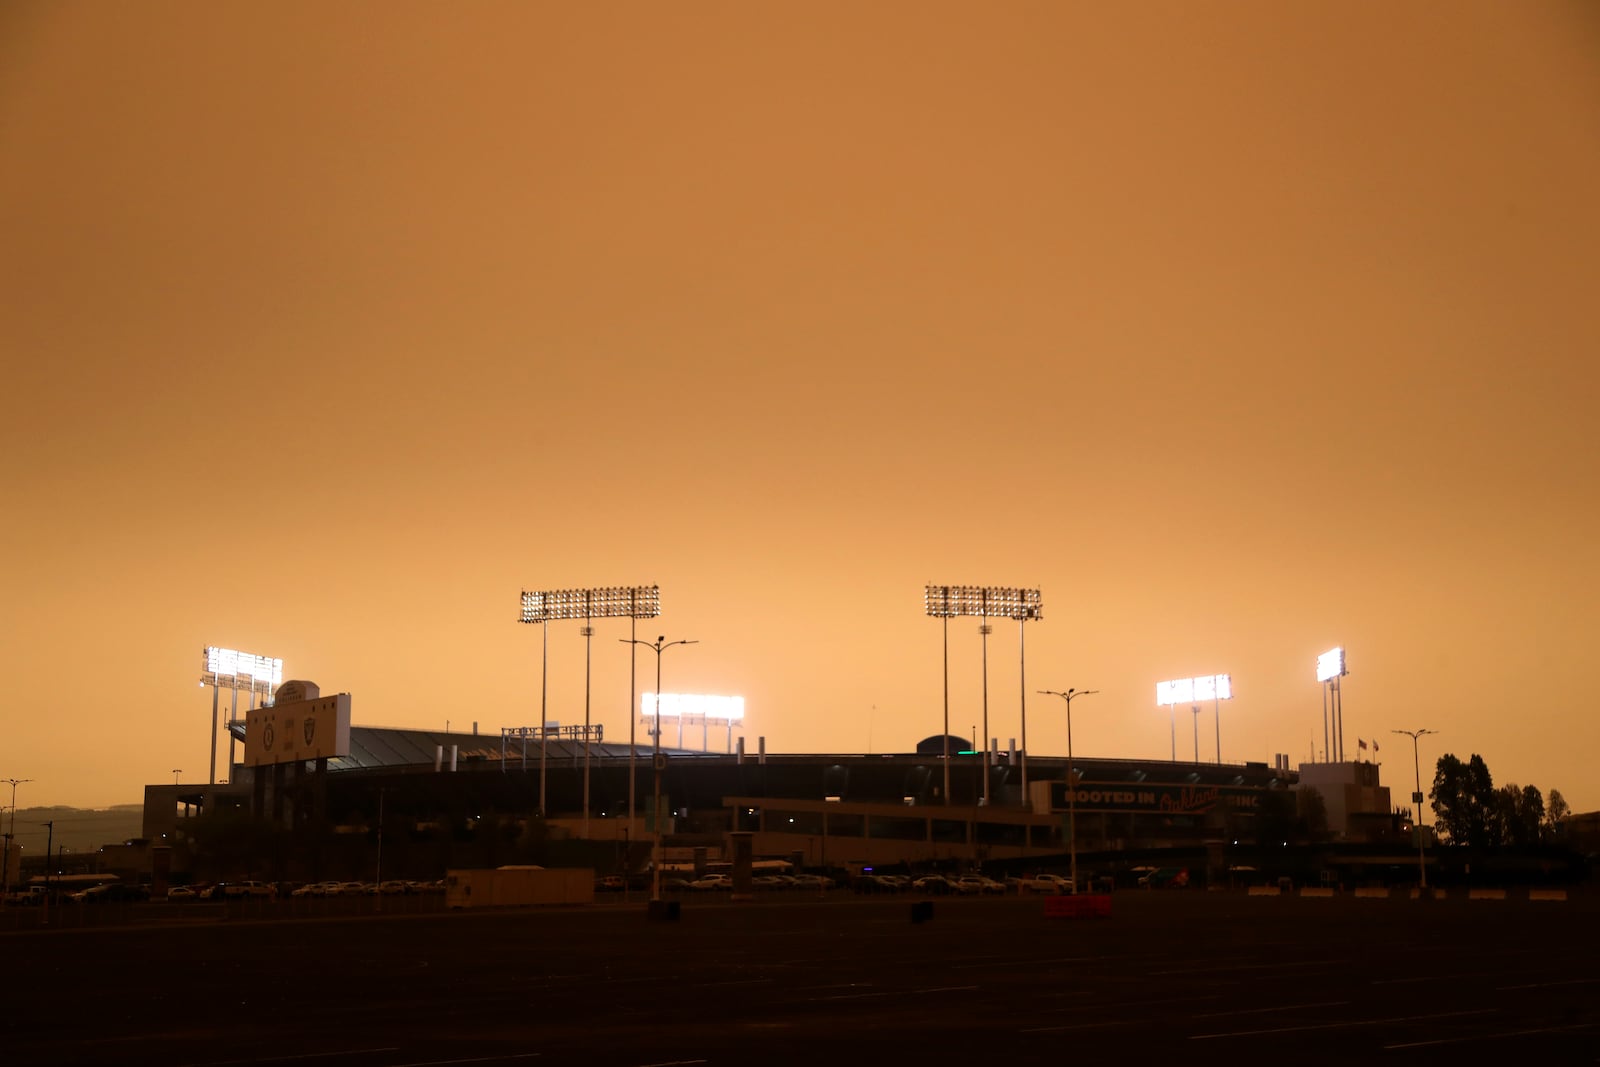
[{"xmin": 0, "ymin": 0, "xmax": 1600, "ymax": 809}]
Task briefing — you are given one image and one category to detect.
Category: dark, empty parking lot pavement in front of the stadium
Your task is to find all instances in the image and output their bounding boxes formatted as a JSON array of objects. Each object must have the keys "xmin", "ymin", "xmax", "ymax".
[{"xmin": 0, "ymin": 893, "xmax": 1600, "ymax": 1067}]
